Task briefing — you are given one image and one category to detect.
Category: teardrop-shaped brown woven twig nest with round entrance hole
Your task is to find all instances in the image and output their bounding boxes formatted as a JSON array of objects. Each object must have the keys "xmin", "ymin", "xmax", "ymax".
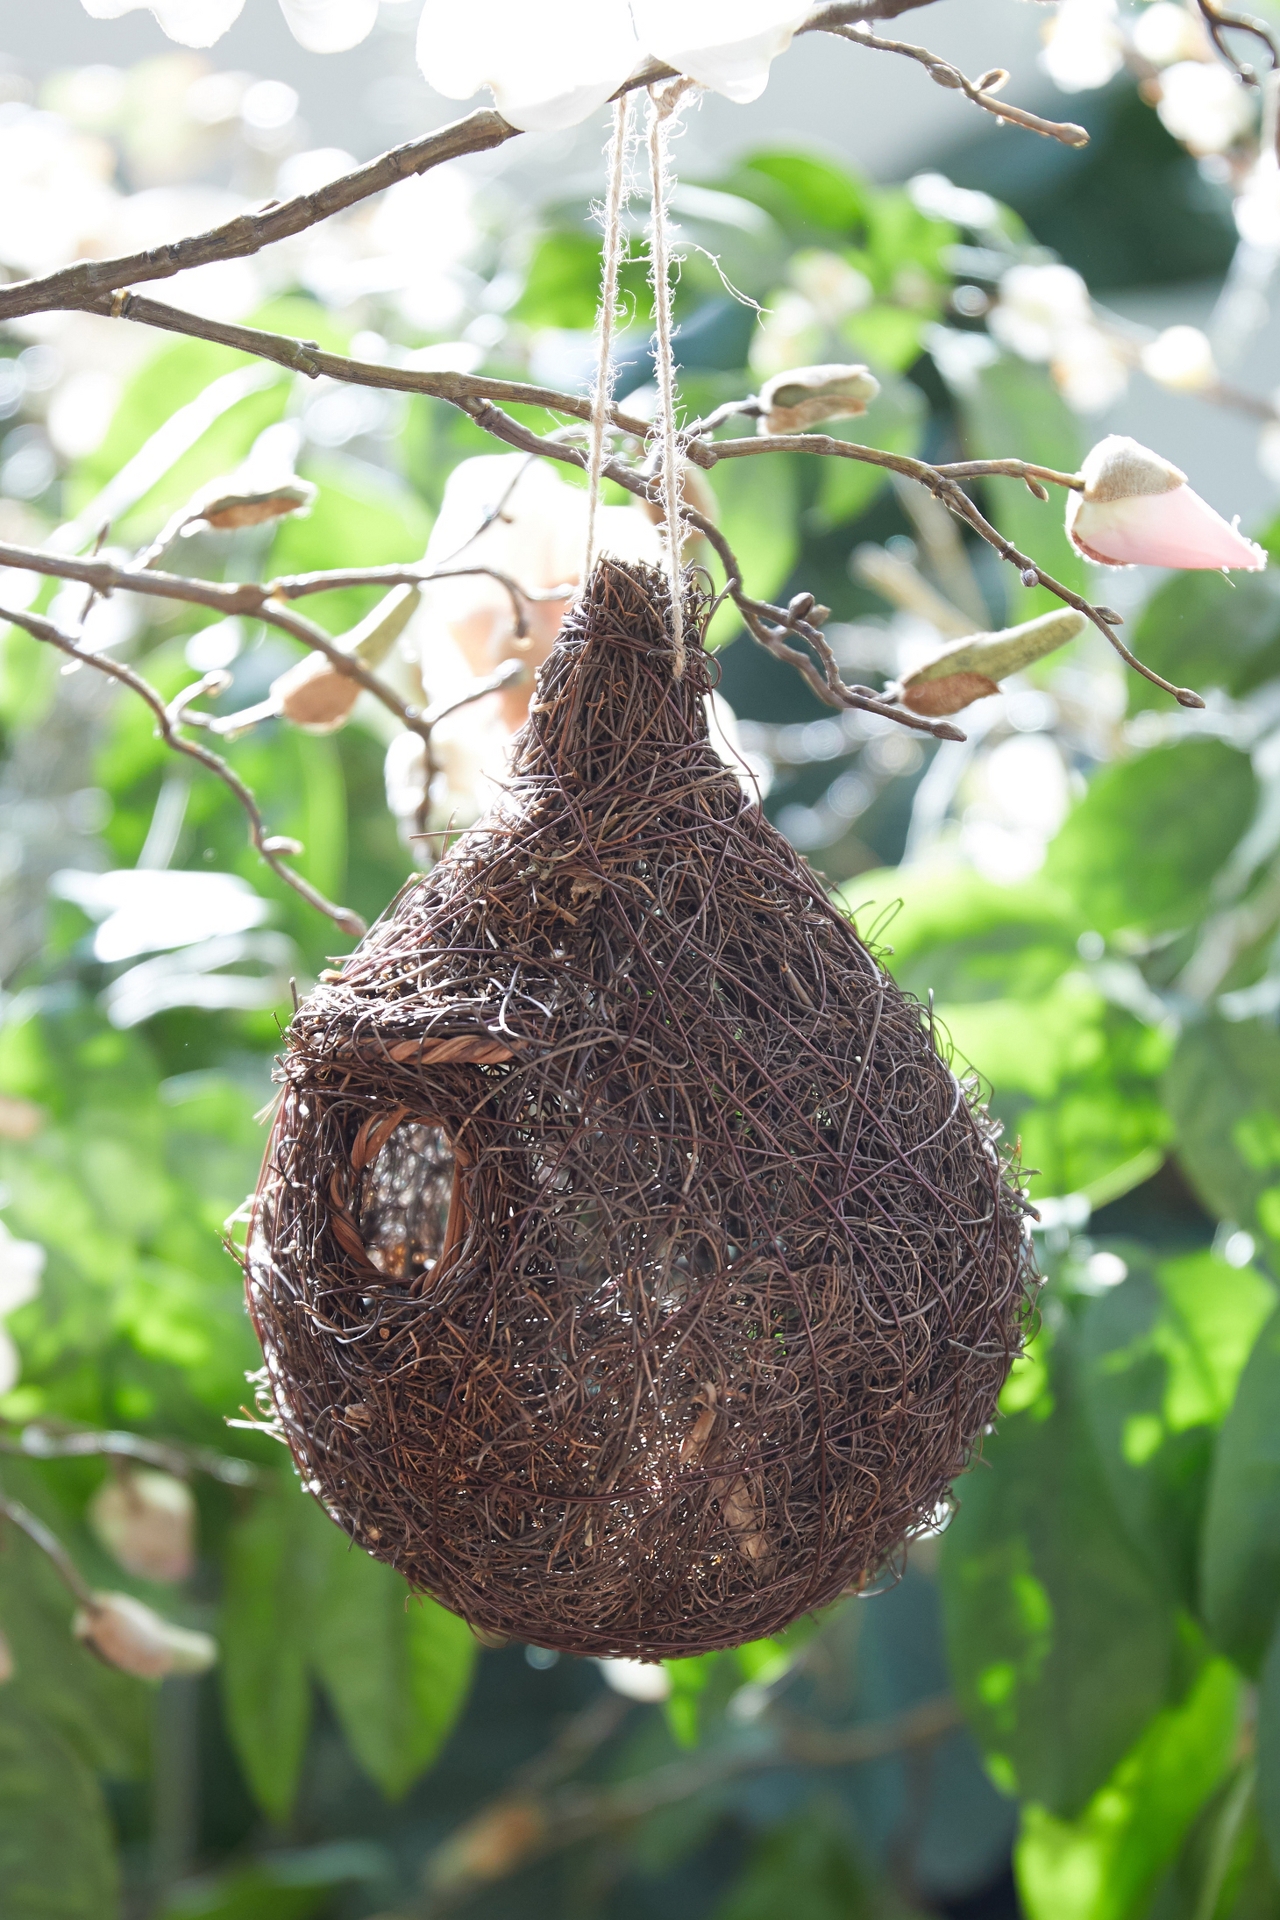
[{"xmin": 248, "ymin": 563, "xmax": 1029, "ymax": 1657}]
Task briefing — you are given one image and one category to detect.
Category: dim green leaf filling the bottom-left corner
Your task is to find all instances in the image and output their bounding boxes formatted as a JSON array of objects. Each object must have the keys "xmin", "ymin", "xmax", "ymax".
[{"xmin": 0, "ymin": 1695, "xmax": 119, "ymax": 1920}]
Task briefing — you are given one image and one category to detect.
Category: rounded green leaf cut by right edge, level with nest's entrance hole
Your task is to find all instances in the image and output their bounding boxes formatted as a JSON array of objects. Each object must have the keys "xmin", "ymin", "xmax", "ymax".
[{"xmin": 1165, "ymin": 1020, "xmax": 1280, "ymax": 1242}]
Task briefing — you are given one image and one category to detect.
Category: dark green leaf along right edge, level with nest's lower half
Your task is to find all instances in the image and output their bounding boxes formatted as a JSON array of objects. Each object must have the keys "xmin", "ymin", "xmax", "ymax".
[{"xmin": 1199, "ymin": 1311, "xmax": 1280, "ymax": 1674}]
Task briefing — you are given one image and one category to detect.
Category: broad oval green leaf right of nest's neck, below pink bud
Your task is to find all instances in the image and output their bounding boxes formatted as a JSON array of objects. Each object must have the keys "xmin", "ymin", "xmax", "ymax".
[{"xmin": 1044, "ymin": 739, "xmax": 1257, "ymax": 933}]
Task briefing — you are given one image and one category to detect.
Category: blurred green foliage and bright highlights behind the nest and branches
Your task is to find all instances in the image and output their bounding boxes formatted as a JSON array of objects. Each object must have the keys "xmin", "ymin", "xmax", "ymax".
[{"xmin": 0, "ymin": 0, "xmax": 1280, "ymax": 1920}]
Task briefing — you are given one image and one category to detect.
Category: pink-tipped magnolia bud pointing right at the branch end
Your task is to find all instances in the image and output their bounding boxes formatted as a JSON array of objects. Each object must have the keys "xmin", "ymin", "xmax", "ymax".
[{"xmin": 1067, "ymin": 434, "xmax": 1267, "ymax": 572}]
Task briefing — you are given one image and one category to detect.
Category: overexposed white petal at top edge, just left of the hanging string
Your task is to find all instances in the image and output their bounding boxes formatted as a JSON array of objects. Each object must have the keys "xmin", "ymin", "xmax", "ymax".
[{"xmin": 418, "ymin": 0, "xmax": 641, "ymax": 132}]
